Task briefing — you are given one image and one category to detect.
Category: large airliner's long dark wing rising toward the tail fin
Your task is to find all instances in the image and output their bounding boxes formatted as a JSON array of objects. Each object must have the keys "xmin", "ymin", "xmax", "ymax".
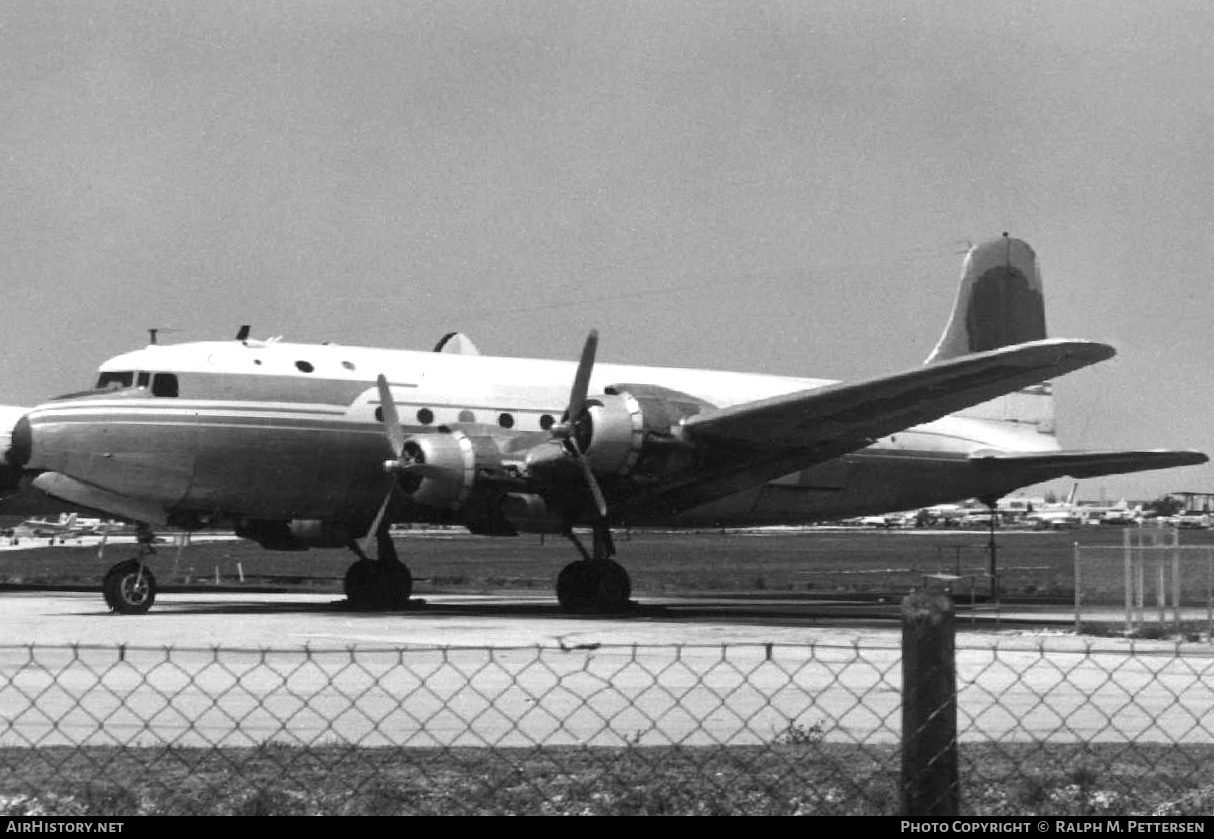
[{"xmin": 683, "ymin": 339, "xmax": 1114, "ymax": 453}]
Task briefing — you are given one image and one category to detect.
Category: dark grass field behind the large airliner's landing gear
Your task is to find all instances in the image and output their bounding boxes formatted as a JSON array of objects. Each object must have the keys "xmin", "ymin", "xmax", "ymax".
[{"xmin": 0, "ymin": 527, "xmax": 1214, "ymax": 599}]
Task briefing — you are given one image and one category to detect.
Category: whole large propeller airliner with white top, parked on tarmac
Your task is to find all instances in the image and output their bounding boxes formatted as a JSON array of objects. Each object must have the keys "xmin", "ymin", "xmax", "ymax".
[{"xmin": 0, "ymin": 234, "xmax": 1207, "ymax": 612}]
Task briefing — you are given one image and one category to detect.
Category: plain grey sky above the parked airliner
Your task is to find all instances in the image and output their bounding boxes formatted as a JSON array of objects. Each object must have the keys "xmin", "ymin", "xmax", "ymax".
[{"xmin": 0, "ymin": 0, "xmax": 1214, "ymax": 500}]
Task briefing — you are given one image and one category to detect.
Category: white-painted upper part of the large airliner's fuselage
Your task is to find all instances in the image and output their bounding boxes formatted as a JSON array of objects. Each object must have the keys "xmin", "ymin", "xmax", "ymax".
[{"xmin": 94, "ymin": 341, "xmax": 1057, "ymax": 455}]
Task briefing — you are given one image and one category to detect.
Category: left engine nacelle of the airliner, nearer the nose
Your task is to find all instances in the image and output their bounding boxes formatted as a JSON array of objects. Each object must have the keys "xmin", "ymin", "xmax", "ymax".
[{"xmin": 401, "ymin": 430, "xmax": 501, "ymax": 510}]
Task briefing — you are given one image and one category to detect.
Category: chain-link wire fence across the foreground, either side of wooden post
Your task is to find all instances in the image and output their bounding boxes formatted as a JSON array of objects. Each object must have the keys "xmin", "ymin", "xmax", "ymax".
[{"xmin": 7, "ymin": 637, "xmax": 1214, "ymax": 815}]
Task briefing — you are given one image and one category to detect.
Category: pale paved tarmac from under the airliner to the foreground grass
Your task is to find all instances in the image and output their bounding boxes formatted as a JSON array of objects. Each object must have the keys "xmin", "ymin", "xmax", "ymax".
[{"xmin": 0, "ymin": 591, "xmax": 1214, "ymax": 746}]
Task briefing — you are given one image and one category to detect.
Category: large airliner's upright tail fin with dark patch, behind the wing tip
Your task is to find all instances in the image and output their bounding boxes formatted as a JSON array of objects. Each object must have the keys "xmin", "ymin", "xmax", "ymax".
[{"xmin": 925, "ymin": 233, "xmax": 1054, "ymax": 435}]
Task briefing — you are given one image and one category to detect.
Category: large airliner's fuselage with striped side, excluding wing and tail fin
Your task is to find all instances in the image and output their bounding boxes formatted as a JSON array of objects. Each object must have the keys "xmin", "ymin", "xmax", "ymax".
[{"xmin": 14, "ymin": 341, "xmax": 1056, "ymax": 526}]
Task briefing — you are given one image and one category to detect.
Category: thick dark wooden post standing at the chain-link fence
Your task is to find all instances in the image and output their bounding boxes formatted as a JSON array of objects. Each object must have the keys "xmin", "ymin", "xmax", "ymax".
[{"xmin": 902, "ymin": 591, "xmax": 960, "ymax": 817}]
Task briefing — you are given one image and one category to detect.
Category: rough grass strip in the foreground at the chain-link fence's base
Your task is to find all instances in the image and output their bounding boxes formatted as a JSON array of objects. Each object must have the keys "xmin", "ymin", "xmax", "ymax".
[{"xmin": 0, "ymin": 737, "xmax": 1214, "ymax": 816}]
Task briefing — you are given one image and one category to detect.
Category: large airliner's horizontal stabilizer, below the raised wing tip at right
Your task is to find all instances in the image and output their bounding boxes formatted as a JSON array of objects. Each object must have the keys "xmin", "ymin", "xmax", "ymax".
[{"xmin": 970, "ymin": 449, "xmax": 1209, "ymax": 483}]
